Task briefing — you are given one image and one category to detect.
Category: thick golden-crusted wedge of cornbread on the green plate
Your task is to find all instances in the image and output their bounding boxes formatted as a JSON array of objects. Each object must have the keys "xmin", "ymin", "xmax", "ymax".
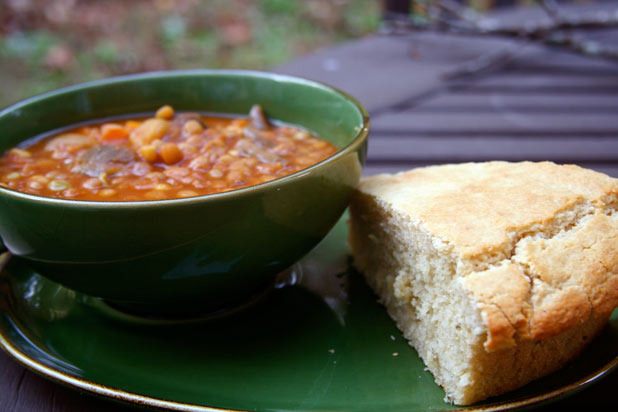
[{"xmin": 349, "ymin": 162, "xmax": 618, "ymax": 405}]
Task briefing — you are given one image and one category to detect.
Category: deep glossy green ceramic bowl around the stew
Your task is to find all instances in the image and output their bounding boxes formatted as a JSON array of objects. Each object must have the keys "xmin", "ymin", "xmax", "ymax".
[{"xmin": 0, "ymin": 70, "xmax": 369, "ymax": 314}]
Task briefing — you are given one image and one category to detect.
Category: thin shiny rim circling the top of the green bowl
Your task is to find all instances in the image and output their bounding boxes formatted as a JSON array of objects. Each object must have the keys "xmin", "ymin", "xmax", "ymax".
[{"xmin": 0, "ymin": 69, "xmax": 369, "ymax": 209}]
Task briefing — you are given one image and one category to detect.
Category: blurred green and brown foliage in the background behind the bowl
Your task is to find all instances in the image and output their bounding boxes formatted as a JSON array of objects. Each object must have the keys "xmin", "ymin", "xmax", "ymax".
[{"xmin": 0, "ymin": 0, "xmax": 381, "ymax": 106}]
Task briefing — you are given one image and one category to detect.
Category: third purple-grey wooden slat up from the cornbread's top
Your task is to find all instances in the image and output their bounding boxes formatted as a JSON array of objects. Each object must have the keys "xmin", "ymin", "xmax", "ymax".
[{"xmin": 414, "ymin": 91, "xmax": 618, "ymax": 114}]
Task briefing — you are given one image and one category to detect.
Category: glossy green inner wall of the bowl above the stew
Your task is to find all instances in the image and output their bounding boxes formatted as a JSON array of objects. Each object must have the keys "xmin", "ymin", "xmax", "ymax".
[{"xmin": 0, "ymin": 70, "xmax": 366, "ymax": 157}]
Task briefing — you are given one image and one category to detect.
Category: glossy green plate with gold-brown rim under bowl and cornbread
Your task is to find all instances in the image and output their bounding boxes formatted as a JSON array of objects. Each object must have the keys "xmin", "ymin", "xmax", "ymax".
[{"xmin": 0, "ymin": 220, "xmax": 618, "ymax": 411}]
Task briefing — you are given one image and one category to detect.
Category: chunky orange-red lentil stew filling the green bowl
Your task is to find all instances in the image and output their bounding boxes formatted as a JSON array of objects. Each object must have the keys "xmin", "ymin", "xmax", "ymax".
[{"xmin": 0, "ymin": 105, "xmax": 337, "ymax": 201}]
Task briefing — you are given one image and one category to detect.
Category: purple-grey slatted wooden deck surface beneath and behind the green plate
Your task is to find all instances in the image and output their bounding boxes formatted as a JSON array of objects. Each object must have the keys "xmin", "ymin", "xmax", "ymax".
[{"xmin": 0, "ymin": 1, "xmax": 618, "ymax": 412}]
